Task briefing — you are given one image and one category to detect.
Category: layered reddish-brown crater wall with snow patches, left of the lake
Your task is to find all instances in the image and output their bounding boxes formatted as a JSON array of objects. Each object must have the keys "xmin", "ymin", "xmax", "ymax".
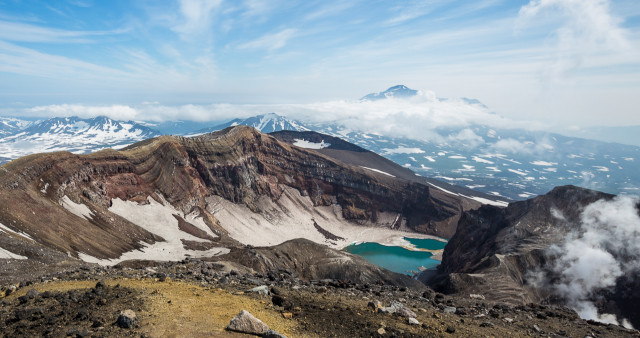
[{"xmin": 0, "ymin": 127, "xmax": 468, "ymax": 266}]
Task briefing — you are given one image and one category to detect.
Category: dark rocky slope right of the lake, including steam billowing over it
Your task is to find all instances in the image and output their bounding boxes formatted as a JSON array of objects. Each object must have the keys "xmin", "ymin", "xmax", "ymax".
[{"xmin": 421, "ymin": 186, "xmax": 640, "ymax": 327}]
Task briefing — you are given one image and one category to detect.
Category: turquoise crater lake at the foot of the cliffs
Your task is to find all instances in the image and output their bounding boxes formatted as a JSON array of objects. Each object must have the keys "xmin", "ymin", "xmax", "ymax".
[{"xmin": 344, "ymin": 237, "xmax": 447, "ymax": 275}]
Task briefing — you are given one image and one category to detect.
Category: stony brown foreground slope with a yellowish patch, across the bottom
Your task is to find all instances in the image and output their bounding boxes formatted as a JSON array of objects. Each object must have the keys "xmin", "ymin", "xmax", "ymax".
[{"xmin": 0, "ymin": 260, "xmax": 640, "ymax": 337}]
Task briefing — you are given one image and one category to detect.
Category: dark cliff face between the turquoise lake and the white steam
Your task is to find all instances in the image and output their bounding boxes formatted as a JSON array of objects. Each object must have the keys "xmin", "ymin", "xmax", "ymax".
[{"xmin": 442, "ymin": 186, "xmax": 613, "ymax": 275}]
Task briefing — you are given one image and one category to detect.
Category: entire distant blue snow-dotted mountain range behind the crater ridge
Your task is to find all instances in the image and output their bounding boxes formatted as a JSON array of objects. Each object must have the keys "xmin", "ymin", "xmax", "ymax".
[{"xmin": 0, "ymin": 85, "xmax": 640, "ymax": 200}]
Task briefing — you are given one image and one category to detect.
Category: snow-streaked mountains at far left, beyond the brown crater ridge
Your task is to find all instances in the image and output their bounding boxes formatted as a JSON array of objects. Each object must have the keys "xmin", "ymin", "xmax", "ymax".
[{"xmin": 0, "ymin": 116, "xmax": 160, "ymax": 162}]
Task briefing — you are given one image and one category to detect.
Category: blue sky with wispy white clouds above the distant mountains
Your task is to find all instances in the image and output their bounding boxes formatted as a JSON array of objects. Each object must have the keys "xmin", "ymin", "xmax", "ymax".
[{"xmin": 0, "ymin": 0, "xmax": 640, "ymax": 125}]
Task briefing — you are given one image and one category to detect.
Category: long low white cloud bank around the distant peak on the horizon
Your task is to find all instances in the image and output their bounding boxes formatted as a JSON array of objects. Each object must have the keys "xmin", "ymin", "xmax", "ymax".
[{"xmin": 14, "ymin": 91, "xmax": 543, "ymax": 141}]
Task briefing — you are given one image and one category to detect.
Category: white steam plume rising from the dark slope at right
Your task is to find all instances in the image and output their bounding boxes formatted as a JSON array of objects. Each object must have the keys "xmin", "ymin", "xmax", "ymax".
[{"xmin": 549, "ymin": 196, "xmax": 640, "ymax": 327}]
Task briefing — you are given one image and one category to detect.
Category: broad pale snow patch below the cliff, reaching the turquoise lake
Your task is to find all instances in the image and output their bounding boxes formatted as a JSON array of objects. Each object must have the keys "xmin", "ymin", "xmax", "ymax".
[{"xmin": 206, "ymin": 185, "xmax": 435, "ymax": 249}]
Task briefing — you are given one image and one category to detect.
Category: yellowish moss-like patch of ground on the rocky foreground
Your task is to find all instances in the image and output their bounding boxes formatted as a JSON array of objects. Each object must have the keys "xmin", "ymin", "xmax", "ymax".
[{"xmin": 9, "ymin": 279, "xmax": 299, "ymax": 337}]
